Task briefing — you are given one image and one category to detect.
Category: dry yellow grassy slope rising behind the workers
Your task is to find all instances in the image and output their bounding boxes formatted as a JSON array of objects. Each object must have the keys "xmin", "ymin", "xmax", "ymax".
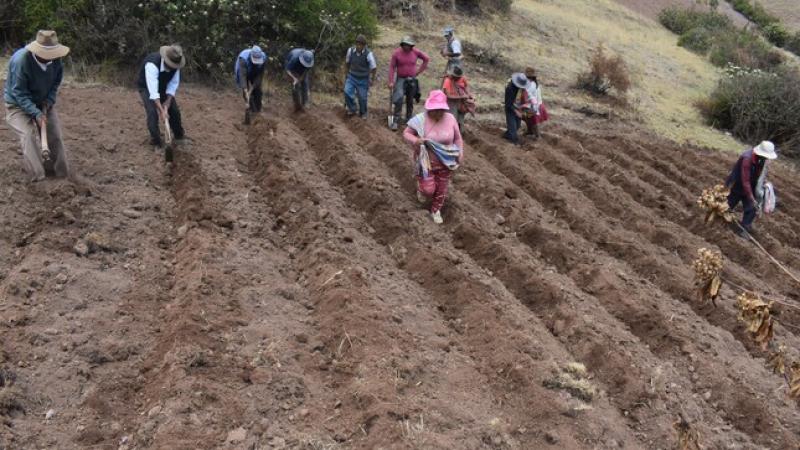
[{"xmin": 373, "ymin": 0, "xmax": 739, "ymax": 148}]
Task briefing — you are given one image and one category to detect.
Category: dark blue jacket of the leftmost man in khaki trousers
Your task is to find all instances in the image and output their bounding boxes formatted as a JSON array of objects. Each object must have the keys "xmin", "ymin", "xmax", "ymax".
[{"xmin": 3, "ymin": 48, "xmax": 64, "ymax": 117}]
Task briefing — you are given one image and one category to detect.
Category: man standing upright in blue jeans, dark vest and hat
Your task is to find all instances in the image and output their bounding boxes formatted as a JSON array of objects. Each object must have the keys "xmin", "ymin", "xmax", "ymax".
[{"xmin": 344, "ymin": 34, "xmax": 378, "ymax": 119}]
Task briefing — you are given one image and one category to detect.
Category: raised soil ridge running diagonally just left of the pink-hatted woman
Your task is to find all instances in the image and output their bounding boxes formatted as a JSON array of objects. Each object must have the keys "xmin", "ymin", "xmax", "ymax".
[{"xmin": 290, "ymin": 110, "xmax": 648, "ymax": 447}]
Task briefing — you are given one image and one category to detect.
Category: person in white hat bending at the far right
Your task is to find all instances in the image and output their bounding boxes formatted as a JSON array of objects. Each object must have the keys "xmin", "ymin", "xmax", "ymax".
[{"xmin": 725, "ymin": 141, "xmax": 778, "ymax": 237}]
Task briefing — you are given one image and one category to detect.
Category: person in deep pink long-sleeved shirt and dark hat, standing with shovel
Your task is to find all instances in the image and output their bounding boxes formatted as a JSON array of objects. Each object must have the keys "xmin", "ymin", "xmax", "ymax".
[{"xmin": 389, "ymin": 36, "xmax": 430, "ymax": 130}]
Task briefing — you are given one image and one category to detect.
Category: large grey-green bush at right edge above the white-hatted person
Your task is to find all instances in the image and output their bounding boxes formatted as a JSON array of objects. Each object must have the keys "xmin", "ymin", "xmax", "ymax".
[{"xmin": 697, "ymin": 65, "xmax": 800, "ymax": 156}]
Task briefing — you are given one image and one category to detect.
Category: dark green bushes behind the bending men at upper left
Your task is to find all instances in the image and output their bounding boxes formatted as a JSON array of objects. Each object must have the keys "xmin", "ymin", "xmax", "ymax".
[{"xmin": 6, "ymin": 0, "xmax": 377, "ymax": 78}]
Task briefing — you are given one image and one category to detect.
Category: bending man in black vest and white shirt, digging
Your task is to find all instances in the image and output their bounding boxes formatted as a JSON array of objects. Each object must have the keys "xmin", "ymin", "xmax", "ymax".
[{"xmin": 137, "ymin": 44, "xmax": 186, "ymax": 148}]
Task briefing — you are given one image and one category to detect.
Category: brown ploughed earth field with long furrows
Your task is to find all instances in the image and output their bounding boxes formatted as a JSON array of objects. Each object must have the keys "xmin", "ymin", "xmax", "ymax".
[{"xmin": 0, "ymin": 85, "xmax": 800, "ymax": 449}]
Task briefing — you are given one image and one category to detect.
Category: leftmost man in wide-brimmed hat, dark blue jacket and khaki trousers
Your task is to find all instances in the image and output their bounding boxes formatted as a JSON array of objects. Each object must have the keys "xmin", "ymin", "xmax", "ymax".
[{"xmin": 3, "ymin": 30, "xmax": 70, "ymax": 182}]
